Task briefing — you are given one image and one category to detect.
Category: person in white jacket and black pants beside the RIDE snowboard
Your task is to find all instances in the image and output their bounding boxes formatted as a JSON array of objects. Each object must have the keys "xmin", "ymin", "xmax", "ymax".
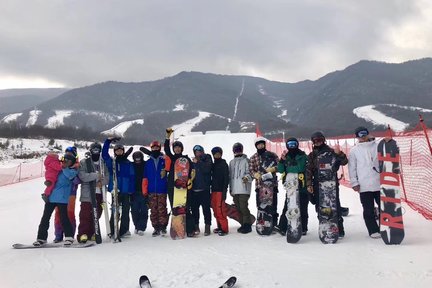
[{"xmin": 348, "ymin": 127, "xmax": 381, "ymax": 238}]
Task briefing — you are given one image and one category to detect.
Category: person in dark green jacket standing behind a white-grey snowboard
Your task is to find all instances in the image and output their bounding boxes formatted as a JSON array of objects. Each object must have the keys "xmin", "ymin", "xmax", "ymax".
[{"xmin": 275, "ymin": 137, "xmax": 309, "ymax": 235}]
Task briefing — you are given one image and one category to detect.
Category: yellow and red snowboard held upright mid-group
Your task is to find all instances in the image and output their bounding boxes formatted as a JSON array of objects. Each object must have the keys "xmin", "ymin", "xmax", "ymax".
[{"xmin": 170, "ymin": 157, "xmax": 190, "ymax": 240}]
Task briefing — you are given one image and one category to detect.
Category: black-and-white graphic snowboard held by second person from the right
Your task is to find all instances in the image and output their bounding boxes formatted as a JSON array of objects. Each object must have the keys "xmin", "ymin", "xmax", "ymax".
[{"xmin": 318, "ymin": 151, "xmax": 339, "ymax": 244}]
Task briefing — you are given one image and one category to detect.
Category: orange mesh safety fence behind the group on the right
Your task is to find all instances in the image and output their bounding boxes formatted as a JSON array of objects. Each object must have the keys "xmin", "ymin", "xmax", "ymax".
[{"xmin": 267, "ymin": 117, "xmax": 432, "ymax": 220}]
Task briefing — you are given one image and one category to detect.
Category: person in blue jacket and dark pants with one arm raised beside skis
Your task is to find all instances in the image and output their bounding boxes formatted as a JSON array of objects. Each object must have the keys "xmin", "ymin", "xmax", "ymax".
[{"xmin": 102, "ymin": 137, "xmax": 135, "ymax": 237}]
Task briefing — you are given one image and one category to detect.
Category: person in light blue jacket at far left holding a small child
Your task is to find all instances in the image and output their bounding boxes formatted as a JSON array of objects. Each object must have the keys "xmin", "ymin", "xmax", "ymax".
[{"xmin": 33, "ymin": 154, "xmax": 78, "ymax": 246}]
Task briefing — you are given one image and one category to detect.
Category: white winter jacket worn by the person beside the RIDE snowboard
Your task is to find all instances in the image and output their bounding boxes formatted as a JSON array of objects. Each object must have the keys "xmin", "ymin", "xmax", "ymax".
[{"xmin": 348, "ymin": 141, "xmax": 380, "ymax": 192}]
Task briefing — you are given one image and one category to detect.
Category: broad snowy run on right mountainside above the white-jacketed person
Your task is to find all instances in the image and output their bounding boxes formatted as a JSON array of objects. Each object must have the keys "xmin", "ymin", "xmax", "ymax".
[{"xmin": 353, "ymin": 105, "xmax": 409, "ymax": 132}]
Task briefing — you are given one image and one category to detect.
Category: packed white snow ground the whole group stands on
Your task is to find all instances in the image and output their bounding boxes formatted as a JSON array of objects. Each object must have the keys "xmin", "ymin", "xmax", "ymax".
[{"xmin": 0, "ymin": 132, "xmax": 432, "ymax": 288}]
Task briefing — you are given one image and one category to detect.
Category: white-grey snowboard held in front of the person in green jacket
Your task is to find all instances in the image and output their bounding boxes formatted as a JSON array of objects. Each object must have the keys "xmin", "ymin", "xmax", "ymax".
[{"xmin": 284, "ymin": 173, "xmax": 302, "ymax": 243}]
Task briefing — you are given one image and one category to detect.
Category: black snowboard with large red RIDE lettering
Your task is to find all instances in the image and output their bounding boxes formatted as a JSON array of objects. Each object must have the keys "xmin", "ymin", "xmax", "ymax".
[{"xmin": 378, "ymin": 139, "xmax": 405, "ymax": 244}]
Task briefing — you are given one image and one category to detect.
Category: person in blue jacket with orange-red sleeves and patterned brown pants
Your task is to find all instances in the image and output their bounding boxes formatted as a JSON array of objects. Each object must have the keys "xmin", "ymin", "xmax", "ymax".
[{"xmin": 143, "ymin": 141, "xmax": 169, "ymax": 237}]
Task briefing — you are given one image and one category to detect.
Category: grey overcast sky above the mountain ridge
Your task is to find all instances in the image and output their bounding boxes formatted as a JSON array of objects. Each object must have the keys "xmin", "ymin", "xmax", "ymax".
[{"xmin": 0, "ymin": 0, "xmax": 432, "ymax": 89}]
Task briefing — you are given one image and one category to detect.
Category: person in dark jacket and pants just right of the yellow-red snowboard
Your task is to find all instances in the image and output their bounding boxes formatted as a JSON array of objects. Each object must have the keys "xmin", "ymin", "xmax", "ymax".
[{"xmin": 190, "ymin": 145, "xmax": 213, "ymax": 236}]
